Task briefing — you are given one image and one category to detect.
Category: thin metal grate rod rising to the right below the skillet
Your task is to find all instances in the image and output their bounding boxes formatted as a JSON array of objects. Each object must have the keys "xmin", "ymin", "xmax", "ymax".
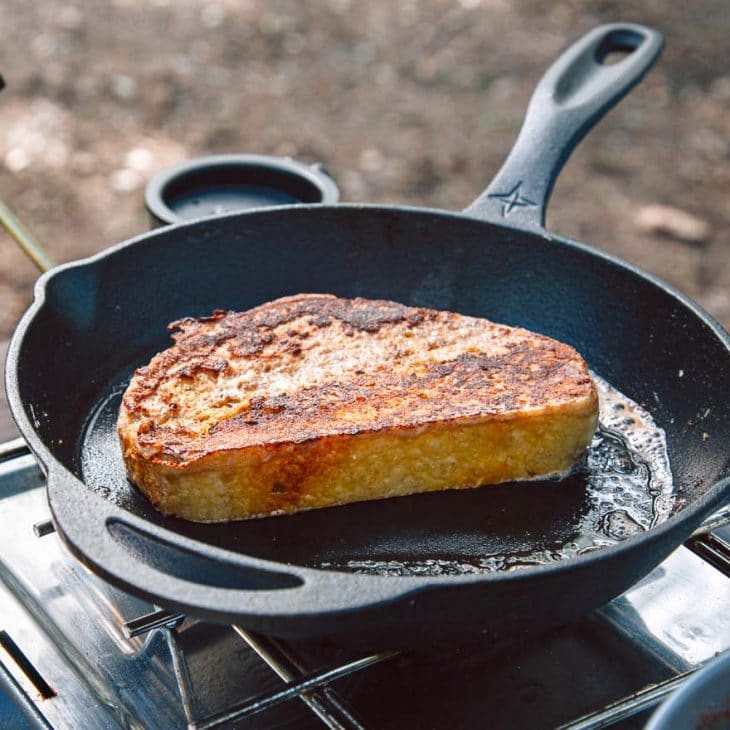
[{"xmin": 190, "ymin": 651, "xmax": 398, "ymax": 730}]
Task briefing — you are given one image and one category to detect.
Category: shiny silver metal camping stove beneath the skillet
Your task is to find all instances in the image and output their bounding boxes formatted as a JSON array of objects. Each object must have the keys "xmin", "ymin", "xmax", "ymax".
[{"xmin": 0, "ymin": 439, "xmax": 730, "ymax": 730}]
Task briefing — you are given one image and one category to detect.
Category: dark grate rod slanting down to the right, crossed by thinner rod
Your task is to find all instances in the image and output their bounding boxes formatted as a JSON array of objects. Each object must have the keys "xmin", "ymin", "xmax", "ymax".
[{"xmin": 233, "ymin": 626, "xmax": 365, "ymax": 730}]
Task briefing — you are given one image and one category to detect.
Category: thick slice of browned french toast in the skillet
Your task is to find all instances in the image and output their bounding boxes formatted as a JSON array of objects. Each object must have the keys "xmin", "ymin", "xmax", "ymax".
[{"xmin": 117, "ymin": 294, "xmax": 598, "ymax": 522}]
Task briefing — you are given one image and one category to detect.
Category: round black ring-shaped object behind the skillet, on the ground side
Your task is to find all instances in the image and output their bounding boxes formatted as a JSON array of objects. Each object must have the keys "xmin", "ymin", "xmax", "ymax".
[{"xmin": 145, "ymin": 155, "xmax": 340, "ymax": 227}]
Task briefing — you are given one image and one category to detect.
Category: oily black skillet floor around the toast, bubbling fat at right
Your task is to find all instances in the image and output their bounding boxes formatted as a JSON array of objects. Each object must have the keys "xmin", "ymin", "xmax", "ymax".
[{"xmin": 80, "ymin": 375, "xmax": 677, "ymax": 576}]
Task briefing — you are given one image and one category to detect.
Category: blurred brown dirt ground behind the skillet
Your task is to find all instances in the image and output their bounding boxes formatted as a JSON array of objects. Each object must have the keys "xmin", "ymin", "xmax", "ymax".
[{"xmin": 0, "ymin": 0, "xmax": 730, "ymax": 339}]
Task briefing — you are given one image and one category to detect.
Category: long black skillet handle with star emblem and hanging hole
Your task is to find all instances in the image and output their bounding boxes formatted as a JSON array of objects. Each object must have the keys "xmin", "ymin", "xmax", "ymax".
[{"xmin": 464, "ymin": 23, "xmax": 664, "ymax": 228}]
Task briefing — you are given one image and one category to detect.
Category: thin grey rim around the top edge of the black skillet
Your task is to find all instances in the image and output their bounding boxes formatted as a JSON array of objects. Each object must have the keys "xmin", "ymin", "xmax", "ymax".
[{"xmin": 5, "ymin": 203, "xmax": 730, "ymax": 618}]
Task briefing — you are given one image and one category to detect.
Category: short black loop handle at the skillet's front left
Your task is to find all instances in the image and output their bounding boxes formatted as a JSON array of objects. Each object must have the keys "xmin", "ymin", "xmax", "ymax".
[{"xmin": 47, "ymin": 461, "xmax": 408, "ymax": 620}]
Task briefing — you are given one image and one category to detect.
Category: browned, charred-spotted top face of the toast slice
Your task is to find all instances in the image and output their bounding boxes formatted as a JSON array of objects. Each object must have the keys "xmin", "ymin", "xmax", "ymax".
[{"xmin": 119, "ymin": 294, "xmax": 597, "ymax": 469}]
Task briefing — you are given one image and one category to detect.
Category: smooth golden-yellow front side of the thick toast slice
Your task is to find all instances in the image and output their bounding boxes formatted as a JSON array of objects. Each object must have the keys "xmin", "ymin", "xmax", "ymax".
[{"xmin": 121, "ymin": 403, "xmax": 596, "ymax": 522}]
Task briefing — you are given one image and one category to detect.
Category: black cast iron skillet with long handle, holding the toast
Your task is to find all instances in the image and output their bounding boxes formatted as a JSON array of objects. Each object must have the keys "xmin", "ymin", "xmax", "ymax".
[{"xmin": 7, "ymin": 24, "xmax": 730, "ymax": 645}]
